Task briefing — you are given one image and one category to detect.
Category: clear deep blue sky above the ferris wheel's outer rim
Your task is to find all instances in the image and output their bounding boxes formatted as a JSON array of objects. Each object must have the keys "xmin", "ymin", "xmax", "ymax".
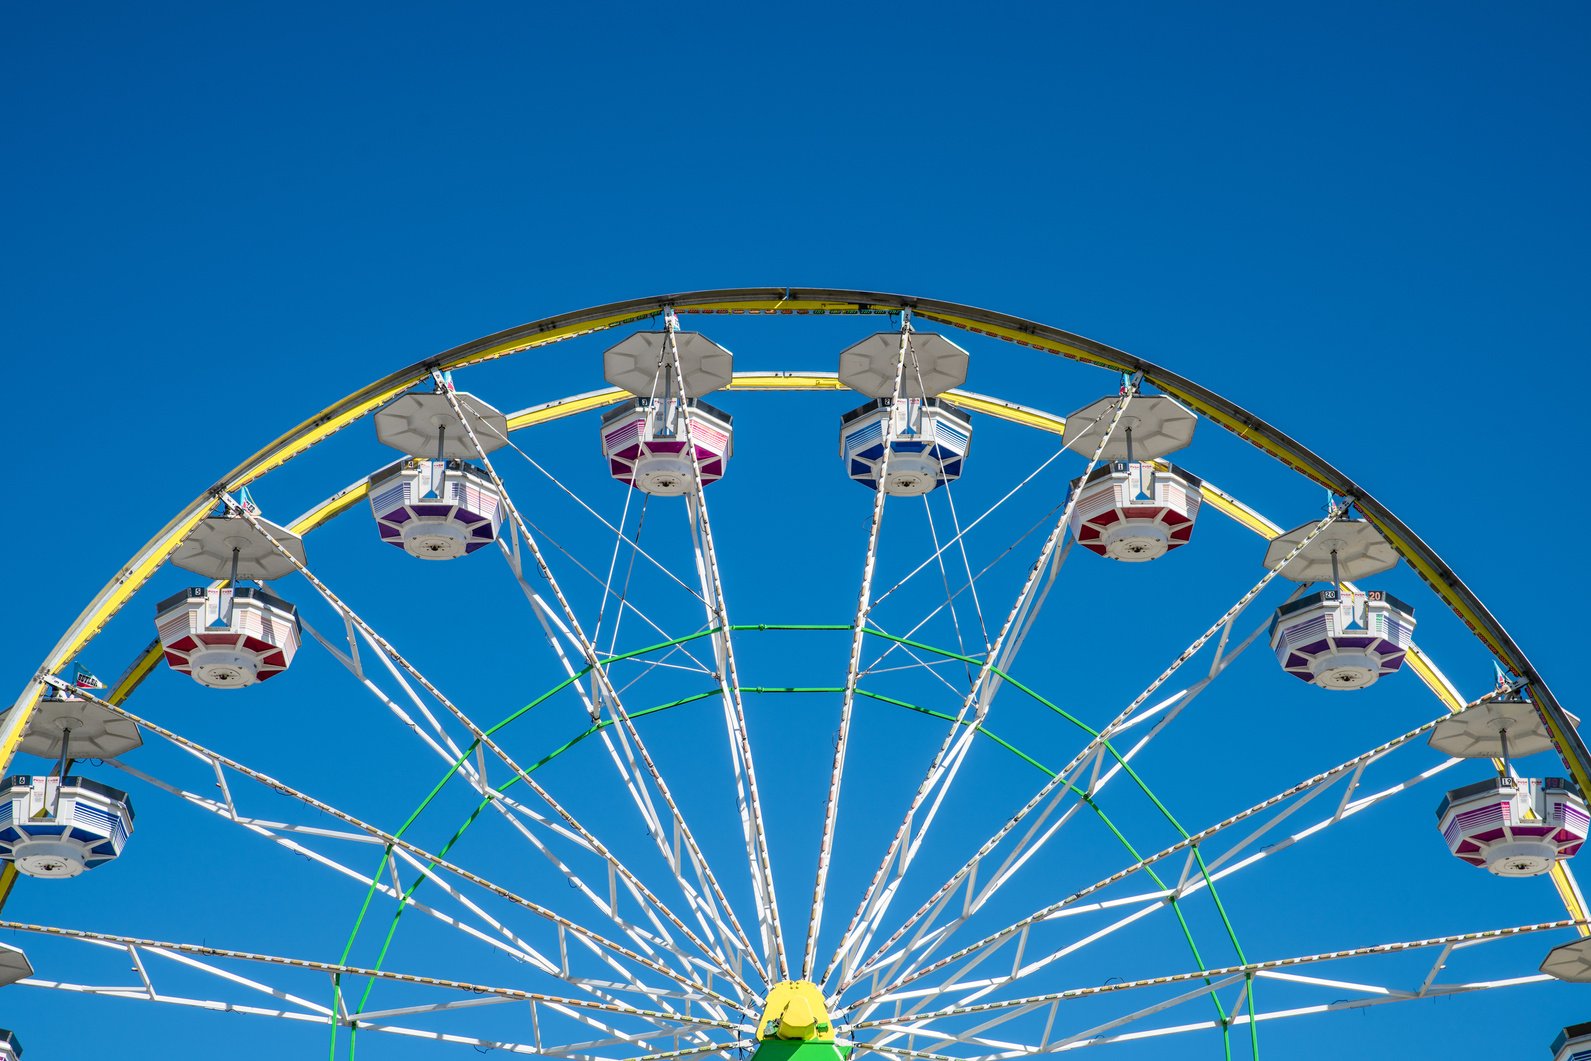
[{"xmin": 0, "ymin": 3, "xmax": 1591, "ymax": 1059}]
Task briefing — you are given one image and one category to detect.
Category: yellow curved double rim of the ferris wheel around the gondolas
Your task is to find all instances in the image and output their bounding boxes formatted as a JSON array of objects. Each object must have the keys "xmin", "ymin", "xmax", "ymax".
[{"xmin": 9, "ymin": 288, "xmax": 1591, "ymax": 935}]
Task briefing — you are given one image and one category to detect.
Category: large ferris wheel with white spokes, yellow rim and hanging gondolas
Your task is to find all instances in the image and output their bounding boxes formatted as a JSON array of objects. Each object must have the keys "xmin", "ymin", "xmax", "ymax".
[{"xmin": 0, "ymin": 290, "xmax": 1591, "ymax": 1061}]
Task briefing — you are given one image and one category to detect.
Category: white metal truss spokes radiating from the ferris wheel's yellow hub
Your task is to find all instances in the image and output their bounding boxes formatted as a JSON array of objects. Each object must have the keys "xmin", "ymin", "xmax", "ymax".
[{"xmin": 0, "ymin": 286, "xmax": 1585, "ymax": 1061}]
